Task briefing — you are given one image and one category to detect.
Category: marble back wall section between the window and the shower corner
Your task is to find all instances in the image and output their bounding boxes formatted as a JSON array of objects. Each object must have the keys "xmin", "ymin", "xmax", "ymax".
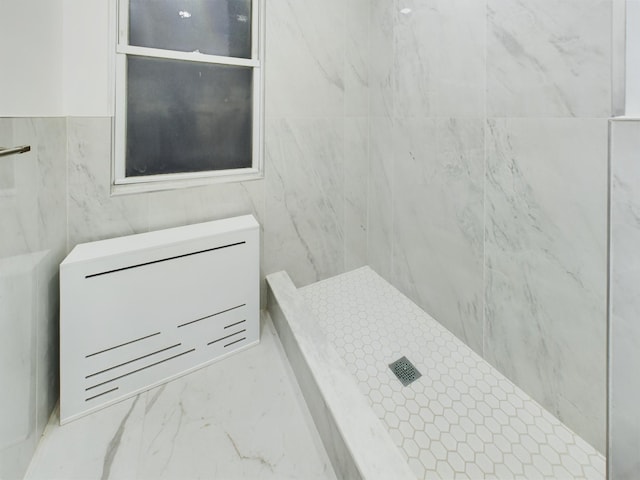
[{"xmin": 264, "ymin": 0, "xmax": 369, "ymax": 285}]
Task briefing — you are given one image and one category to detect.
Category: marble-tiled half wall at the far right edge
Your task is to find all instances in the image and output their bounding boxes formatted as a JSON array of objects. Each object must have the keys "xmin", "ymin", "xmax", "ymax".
[{"xmin": 609, "ymin": 119, "xmax": 640, "ymax": 480}]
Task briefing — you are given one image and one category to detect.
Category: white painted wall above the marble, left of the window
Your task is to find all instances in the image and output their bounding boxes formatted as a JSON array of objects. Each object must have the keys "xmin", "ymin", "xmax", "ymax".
[{"xmin": 0, "ymin": 0, "xmax": 115, "ymax": 117}]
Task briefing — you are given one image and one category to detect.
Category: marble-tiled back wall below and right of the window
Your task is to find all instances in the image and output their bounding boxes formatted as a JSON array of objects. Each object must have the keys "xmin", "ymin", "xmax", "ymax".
[{"xmin": 68, "ymin": 0, "xmax": 369, "ymax": 285}]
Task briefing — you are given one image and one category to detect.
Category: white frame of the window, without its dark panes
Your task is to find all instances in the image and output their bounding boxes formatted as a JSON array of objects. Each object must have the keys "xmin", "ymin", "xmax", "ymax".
[{"xmin": 111, "ymin": 0, "xmax": 265, "ymax": 195}]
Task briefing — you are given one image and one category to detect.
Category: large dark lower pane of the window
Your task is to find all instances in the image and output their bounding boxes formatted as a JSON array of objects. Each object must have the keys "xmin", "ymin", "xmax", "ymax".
[{"xmin": 126, "ymin": 56, "xmax": 253, "ymax": 177}]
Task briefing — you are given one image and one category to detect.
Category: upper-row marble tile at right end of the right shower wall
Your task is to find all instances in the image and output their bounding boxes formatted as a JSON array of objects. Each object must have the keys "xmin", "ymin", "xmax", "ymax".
[{"xmin": 487, "ymin": 0, "xmax": 612, "ymax": 117}]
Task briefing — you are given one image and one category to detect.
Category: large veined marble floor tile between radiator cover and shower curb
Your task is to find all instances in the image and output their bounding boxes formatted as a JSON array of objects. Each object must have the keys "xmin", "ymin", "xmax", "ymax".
[{"xmin": 137, "ymin": 321, "xmax": 331, "ymax": 479}]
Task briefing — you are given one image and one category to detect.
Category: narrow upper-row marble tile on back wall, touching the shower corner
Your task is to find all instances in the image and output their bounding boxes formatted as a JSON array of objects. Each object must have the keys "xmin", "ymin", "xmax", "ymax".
[{"xmin": 344, "ymin": 0, "xmax": 371, "ymax": 117}]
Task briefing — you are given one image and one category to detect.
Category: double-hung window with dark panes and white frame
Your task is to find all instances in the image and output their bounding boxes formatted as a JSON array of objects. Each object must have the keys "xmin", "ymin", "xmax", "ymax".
[{"xmin": 113, "ymin": 0, "xmax": 263, "ymax": 192}]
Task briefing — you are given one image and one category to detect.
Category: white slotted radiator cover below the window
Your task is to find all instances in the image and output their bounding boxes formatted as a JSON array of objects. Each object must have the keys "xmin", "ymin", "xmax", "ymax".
[{"xmin": 60, "ymin": 215, "xmax": 260, "ymax": 424}]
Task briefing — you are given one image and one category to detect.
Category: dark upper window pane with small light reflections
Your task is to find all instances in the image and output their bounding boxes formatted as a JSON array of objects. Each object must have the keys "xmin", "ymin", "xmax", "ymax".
[{"xmin": 129, "ymin": 0, "xmax": 251, "ymax": 58}]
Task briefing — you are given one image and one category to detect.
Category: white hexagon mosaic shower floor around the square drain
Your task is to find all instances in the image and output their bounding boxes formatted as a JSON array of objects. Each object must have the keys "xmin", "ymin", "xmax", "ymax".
[{"xmin": 300, "ymin": 267, "xmax": 605, "ymax": 480}]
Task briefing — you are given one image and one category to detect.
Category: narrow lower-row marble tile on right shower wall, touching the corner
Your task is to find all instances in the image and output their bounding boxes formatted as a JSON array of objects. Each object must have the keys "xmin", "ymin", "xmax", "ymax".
[{"xmin": 367, "ymin": 117, "xmax": 394, "ymax": 278}]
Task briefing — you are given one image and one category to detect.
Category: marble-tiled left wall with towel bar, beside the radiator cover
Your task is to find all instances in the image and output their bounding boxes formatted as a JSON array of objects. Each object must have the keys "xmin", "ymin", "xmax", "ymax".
[{"xmin": 0, "ymin": 118, "xmax": 67, "ymax": 478}]
